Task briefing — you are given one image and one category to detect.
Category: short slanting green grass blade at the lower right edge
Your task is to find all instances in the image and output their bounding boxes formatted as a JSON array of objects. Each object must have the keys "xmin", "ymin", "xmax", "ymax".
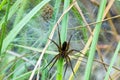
[{"xmin": 104, "ymin": 41, "xmax": 120, "ymax": 80}]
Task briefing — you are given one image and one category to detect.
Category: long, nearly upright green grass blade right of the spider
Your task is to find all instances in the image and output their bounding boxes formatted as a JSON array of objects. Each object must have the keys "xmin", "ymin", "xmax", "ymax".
[{"xmin": 85, "ymin": 0, "xmax": 107, "ymax": 80}]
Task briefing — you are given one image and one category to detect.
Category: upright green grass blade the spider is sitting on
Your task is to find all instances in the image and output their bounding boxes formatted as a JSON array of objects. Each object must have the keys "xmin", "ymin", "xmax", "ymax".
[{"xmin": 56, "ymin": 0, "xmax": 70, "ymax": 80}]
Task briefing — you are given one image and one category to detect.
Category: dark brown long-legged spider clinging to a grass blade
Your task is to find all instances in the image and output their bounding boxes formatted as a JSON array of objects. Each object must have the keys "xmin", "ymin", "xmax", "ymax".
[{"xmin": 44, "ymin": 27, "xmax": 79, "ymax": 76}]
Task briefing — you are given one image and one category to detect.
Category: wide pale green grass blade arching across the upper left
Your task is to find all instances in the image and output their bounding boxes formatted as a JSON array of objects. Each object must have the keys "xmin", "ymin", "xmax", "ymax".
[{"xmin": 1, "ymin": 0, "xmax": 50, "ymax": 53}]
